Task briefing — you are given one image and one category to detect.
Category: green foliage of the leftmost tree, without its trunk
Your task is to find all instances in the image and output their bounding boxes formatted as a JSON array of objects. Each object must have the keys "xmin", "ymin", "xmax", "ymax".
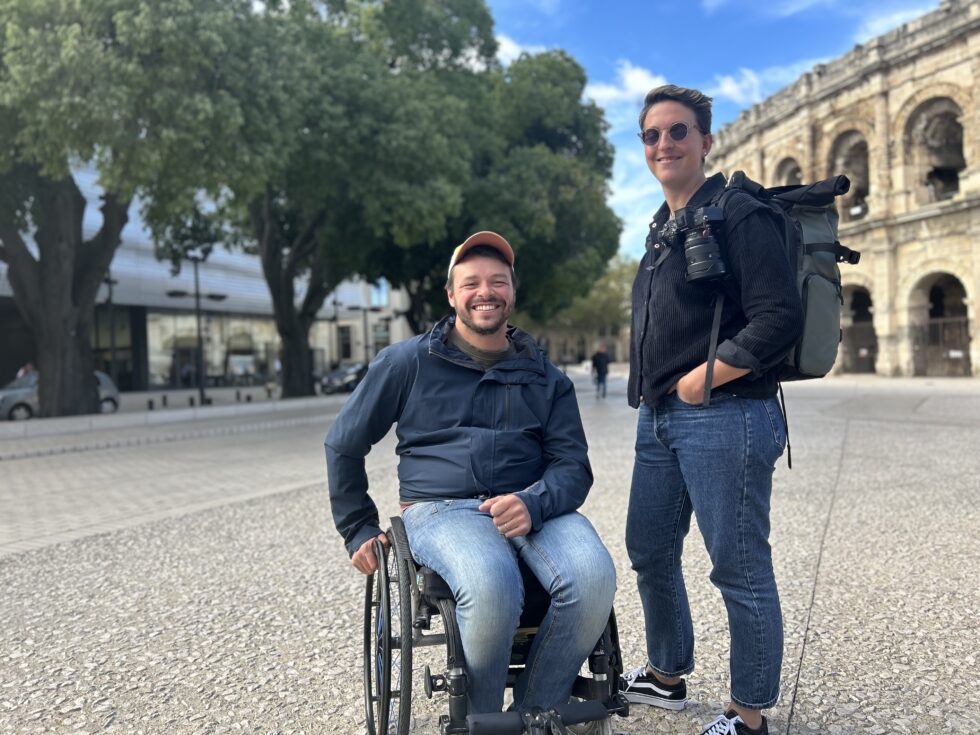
[{"xmin": 0, "ymin": 0, "xmax": 289, "ymax": 226}]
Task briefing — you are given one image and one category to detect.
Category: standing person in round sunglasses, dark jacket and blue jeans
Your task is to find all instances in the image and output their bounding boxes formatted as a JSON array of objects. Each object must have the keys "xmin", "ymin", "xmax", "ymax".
[{"xmin": 623, "ymin": 85, "xmax": 803, "ymax": 735}]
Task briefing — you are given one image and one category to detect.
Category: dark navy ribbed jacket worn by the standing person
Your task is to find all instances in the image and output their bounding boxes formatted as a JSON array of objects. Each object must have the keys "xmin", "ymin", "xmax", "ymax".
[{"xmin": 628, "ymin": 173, "xmax": 803, "ymax": 408}]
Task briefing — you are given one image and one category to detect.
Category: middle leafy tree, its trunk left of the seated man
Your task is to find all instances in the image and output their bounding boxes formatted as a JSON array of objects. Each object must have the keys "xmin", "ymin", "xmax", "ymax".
[{"xmin": 186, "ymin": 0, "xmax": 495, "ymax": 396}]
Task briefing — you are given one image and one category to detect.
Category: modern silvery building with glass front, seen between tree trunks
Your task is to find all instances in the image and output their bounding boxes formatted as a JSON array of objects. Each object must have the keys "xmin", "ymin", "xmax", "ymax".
[{"xmin": 0, "ymin": 171, "xmax": 410, "ymax": 390}]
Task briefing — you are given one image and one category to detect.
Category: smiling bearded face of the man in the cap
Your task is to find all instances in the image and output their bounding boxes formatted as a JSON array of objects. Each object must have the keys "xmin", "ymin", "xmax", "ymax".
[{"xmin": 446, "ymin": 255, "xmax": 514, "ymax": 347}]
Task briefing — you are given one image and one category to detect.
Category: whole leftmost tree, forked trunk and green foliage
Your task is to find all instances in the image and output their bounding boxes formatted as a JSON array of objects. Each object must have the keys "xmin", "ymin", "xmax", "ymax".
[{"xmin": 0, "ymin": 0, "xmax": 288, "ymax": 416}]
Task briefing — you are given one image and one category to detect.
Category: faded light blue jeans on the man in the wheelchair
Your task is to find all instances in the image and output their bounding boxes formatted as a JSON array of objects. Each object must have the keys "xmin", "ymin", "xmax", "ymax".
[{"xmin": 402, "ymin": 500, "xmax": 616, "ymax": 714}]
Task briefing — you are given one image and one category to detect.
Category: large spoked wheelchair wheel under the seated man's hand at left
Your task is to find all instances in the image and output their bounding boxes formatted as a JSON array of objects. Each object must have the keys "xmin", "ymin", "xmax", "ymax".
[{"xmin": 364, "ymin": 541, "xmax": 415, "ymax": 735}]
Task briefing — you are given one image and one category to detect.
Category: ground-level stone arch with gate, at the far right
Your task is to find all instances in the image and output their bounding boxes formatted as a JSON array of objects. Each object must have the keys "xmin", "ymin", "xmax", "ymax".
[{"xmin": 906, "ymin": 269, "xmax": 972, "ymax": 376}]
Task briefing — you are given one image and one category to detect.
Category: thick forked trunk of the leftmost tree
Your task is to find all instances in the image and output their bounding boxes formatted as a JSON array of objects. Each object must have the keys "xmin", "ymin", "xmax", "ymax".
[{"xmin": 0, "ymin": 168, "xmax": 129, "ymax": 416}]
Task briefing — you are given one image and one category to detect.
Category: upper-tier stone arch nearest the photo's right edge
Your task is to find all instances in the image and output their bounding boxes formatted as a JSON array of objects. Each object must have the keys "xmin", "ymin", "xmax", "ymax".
[{"xmin": 896, "ymin": 84, "xmax": 973, "ymax": 204}]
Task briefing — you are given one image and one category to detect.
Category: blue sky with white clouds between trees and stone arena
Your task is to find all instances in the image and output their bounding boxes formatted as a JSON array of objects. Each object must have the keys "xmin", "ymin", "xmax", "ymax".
[{"xmin": 487, "ymin": 0, "xmax": 939, "ymax": 257}]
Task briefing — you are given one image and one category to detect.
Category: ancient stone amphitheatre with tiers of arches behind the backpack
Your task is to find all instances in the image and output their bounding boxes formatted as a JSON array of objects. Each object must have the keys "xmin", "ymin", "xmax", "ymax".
[{"xmin": 708, "ymin": 0, "xmax": 980, "ymax": 376}]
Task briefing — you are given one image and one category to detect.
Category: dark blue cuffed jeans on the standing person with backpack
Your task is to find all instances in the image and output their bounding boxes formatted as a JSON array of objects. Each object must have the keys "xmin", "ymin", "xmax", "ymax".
[{"xmin": 626, "ymin": 391, "xmax": 786, "ymax": 709}]
